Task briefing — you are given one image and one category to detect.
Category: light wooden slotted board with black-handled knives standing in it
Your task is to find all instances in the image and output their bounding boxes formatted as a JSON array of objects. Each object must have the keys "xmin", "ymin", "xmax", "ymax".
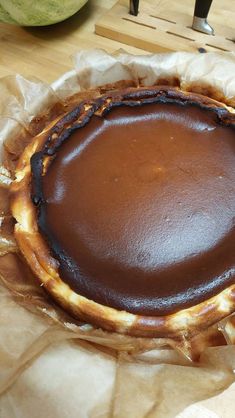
[{"xmin": 96, "ymin": 0, "xmax": 235, "ymax": 52}]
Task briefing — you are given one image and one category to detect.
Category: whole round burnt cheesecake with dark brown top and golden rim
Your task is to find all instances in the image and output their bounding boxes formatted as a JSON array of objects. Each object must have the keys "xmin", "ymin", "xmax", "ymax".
[{"xmin": 9, "ymin": 87, "xmax": 235, "ymax": 337}]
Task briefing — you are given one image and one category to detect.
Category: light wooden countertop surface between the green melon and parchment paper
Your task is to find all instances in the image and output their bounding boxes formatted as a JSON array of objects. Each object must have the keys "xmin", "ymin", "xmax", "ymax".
[{"xmin": 0, "ymin": 0, "xmax": 143, "ymax": 82}]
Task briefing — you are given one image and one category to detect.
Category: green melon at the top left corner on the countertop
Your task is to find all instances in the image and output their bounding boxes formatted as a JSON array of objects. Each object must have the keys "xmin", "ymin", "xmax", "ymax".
[{"xmin": 0, "ymin": 0, "xmax": 87, "ymax": 26}]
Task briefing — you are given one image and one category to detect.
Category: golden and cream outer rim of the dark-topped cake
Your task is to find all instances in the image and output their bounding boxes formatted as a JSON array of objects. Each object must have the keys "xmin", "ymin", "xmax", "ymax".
[{"xmin": 11, "ymin": 87, "xmax": 235, "ymax": 339}]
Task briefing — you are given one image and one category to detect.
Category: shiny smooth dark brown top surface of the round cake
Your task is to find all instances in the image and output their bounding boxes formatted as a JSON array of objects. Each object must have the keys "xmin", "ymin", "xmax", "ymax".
[{"xmin": 38, "ymin": 99, "xmax": 235, "ymax": 316}]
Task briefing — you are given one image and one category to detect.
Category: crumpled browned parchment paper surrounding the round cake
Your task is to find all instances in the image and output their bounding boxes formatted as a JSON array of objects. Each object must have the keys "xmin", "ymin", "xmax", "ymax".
[{"xmin": 0, "ymin": 50, "xmax": 235, "ymax": 418}]
